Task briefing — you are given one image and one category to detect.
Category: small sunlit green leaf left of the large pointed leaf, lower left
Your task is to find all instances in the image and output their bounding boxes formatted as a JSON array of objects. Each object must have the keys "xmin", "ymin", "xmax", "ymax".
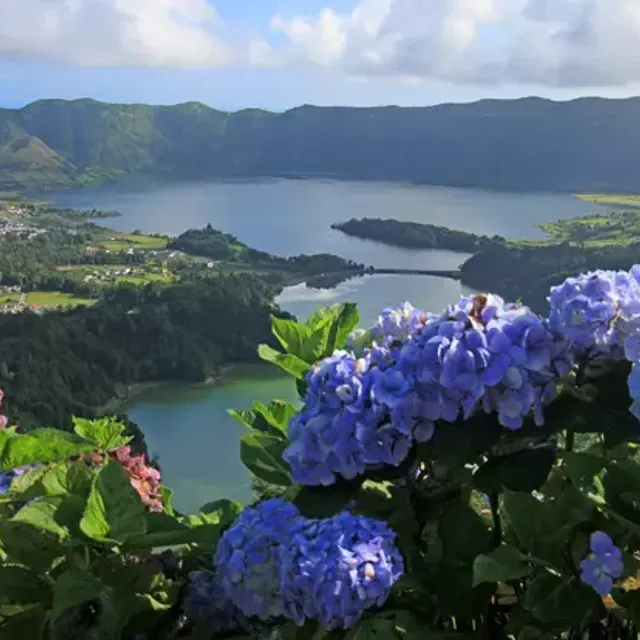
[{"xmin": 12, "ymin": 495, "xmax": 85, "ymax": 540}]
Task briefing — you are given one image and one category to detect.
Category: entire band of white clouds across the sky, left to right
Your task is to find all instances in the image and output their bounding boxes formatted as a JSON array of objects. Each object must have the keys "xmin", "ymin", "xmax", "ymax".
[{"xmin": 0, "ymin": 0, "xmax": 640, "ymax": 87}]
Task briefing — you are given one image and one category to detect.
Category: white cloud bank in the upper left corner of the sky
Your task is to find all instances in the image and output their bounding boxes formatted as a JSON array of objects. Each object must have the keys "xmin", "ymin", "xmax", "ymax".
[{"xmin": 0, "ymin": 0, "xmax": 234, "ymax": 67}]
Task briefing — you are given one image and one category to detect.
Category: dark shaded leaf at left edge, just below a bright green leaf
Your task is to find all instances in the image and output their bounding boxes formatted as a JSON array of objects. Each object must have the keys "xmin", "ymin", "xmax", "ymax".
[{"xmin": 0, "ymin": 520, "xmax": 65, "ymax": 573}]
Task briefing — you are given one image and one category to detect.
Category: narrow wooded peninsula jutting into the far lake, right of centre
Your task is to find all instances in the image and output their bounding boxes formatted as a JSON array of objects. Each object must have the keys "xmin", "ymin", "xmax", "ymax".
[{"xmin": 331, "ymin": 218, "xmax": 507, "ymax": 253}]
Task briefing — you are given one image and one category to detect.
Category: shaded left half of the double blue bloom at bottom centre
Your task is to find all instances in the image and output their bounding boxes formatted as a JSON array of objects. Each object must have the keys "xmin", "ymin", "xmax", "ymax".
[{"xmin": 214, "ymin": 498, "xmax": 301, "ymax": 620}]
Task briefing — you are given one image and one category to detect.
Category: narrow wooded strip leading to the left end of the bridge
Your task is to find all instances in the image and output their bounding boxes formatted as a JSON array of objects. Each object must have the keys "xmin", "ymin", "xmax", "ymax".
[{"xmin": 168, "ymin": 224, "xmax": 365, "ymax": 275}]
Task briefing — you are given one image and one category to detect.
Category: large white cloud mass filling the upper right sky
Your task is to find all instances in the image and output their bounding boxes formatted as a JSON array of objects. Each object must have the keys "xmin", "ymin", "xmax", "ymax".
[{"xmin": 271, "ymin": 0, "xmax": 640, "ymax": 86}]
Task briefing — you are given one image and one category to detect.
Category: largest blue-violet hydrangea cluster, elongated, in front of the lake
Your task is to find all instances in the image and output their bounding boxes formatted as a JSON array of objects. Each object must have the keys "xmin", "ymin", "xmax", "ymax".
[{"xmin": 283, "ymin": 295, "xmax": 572, "ymax": 485}]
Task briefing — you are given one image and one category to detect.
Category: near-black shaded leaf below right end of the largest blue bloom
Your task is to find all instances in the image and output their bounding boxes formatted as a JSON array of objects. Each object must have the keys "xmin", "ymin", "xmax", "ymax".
[{"xmin": 473, "ymin": 445, "xmax": 556, "ymax": 493}]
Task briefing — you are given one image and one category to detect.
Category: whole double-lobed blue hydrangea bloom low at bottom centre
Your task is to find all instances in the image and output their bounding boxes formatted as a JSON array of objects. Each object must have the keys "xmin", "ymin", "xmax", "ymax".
[{"xmin": 211, "ymin": 498, "xmax": 404, "ymax": 629}]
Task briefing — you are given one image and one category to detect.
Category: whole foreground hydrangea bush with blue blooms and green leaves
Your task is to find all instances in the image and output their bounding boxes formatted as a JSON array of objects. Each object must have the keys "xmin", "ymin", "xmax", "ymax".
[{"xmin": 5, "ymin": 267, "xmax": 640, "ymax": 640}]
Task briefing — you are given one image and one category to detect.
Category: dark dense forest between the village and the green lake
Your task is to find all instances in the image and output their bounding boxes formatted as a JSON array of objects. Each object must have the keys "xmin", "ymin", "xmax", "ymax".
[{"xmin": 0, "ymin": 275, "xmax": 286, "ymax": 429}]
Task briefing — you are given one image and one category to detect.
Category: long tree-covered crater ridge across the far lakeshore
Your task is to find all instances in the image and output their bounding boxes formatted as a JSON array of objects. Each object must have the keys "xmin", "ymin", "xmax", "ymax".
[{"xmin": 0, "ymin": 98, "xmax": 640, "ymax": 191}]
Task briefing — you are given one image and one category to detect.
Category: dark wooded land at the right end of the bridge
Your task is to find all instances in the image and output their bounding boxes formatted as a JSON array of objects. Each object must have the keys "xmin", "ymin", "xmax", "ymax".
[{"xmin": 461, "ymin": 243, "xmax": 640, "ymax": 313}]
